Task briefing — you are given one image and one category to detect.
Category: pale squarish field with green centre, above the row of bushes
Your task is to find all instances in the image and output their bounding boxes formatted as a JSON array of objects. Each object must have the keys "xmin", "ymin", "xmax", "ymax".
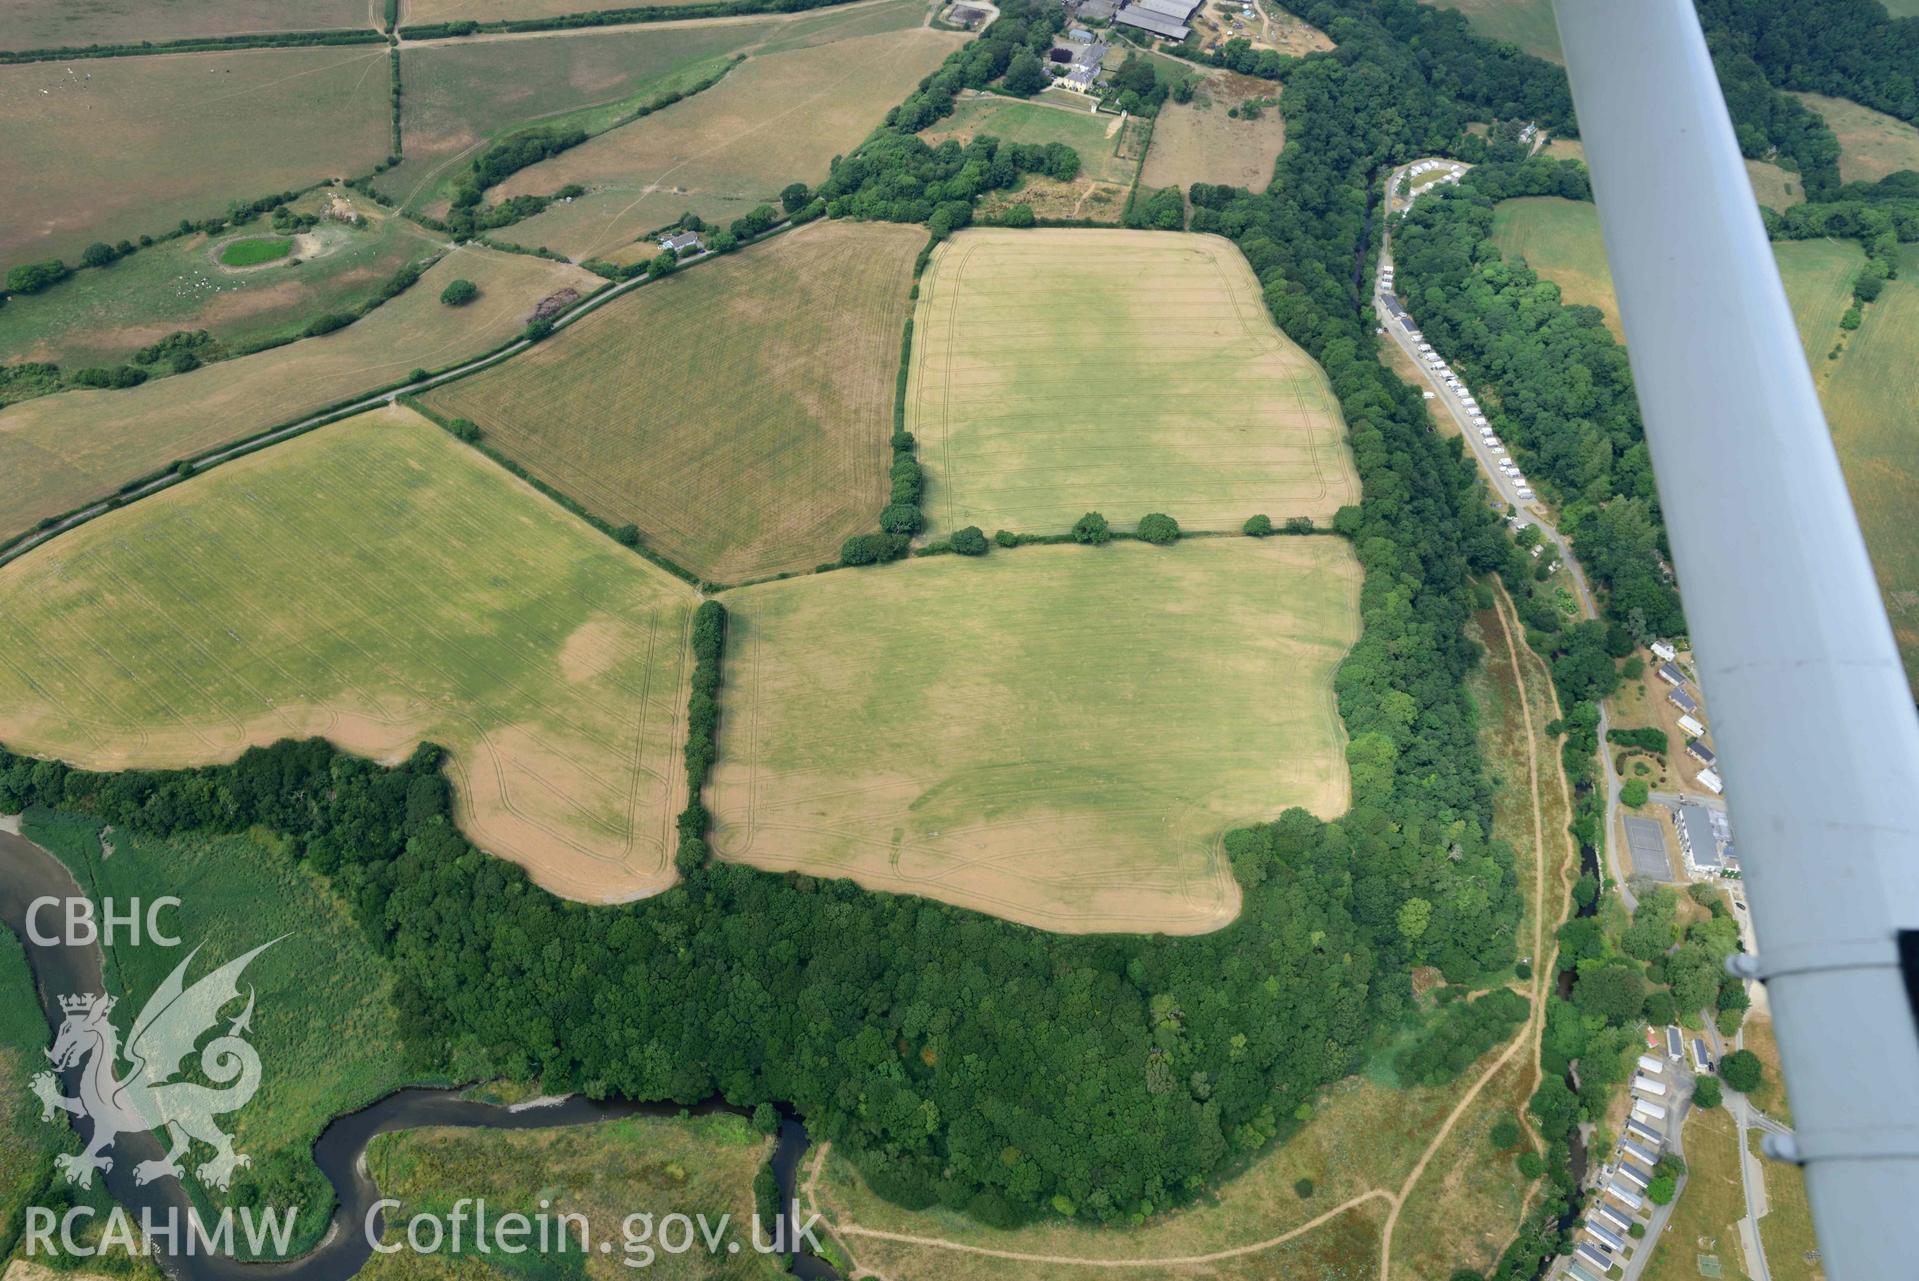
[{"xmin": 906, "ymin": 230, "xmax": 1359, "ymax": 533}]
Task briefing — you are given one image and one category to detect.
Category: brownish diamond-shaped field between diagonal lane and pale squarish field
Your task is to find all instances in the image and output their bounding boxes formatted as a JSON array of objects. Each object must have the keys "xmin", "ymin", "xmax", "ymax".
[{"xmin": 426, "ymin": 222, "xmax": 925, "ymax": 583}]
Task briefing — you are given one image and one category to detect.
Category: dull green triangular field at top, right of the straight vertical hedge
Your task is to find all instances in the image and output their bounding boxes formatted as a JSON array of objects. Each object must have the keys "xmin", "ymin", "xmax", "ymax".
[{"xmin": 374, "ymin": 19, "xmax": 783, "ymax": 209}]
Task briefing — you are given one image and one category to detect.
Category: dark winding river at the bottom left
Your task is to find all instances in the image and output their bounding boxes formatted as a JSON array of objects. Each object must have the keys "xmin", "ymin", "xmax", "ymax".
[{"xmin": 0, "ymin": 832, "xmax": 839, "ymax": 1281}]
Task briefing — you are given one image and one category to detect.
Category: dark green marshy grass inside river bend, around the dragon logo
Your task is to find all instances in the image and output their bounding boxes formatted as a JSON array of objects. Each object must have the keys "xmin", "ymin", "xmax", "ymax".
[{"xmin": 25, "ymin": 811, "xmax": 456, "ymax": 1243}]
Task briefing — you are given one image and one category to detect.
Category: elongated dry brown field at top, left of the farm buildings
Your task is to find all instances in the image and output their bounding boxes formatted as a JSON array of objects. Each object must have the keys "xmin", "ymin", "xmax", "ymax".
[{"xmin": 491, "ymin": 27, "xmax": 967, "ymax": 261}]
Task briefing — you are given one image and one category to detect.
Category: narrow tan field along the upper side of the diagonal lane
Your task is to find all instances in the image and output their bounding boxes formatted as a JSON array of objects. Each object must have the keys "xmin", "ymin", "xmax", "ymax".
[{"xmin": 0, "ymin": 245, "xmax": 603, "ymax": 537}]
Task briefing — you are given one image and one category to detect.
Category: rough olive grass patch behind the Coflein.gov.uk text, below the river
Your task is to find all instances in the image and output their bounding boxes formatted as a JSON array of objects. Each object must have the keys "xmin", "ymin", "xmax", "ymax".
[{"xmin": 359, "ymin": 1112, "xmax": 785, "ymax": 1281}]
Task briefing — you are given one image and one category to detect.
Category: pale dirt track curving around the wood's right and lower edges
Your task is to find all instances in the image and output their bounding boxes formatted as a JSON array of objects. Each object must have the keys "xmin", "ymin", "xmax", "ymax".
[{"xmin": 800, "ymin": 587, "xmax": 1575, "ymax": 1281}]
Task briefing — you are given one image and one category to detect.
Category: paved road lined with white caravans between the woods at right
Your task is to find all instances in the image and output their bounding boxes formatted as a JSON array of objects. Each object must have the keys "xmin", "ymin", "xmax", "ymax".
[{"xmin": 1372, "ymin": 157, "xmax": 1639, "ymax": 911}]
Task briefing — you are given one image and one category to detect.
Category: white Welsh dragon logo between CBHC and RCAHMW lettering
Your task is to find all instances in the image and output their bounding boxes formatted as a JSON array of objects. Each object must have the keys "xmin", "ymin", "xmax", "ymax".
[{"xmin": 33, "ymin": 940, "xmax": 278, "ymax": 1191}]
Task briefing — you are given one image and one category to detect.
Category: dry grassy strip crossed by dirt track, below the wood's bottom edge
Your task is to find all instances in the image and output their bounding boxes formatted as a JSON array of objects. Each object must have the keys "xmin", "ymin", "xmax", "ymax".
[{"xmin": 819, "ymin": 1078, "xmax": 1458, "ymax": 1279}]
